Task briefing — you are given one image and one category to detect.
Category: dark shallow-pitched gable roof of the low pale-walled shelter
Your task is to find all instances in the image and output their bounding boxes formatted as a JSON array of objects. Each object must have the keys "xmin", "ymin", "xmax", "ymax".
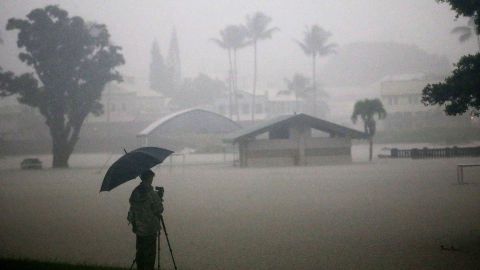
[{"xmin": 223, "ymin": 113, "xmax": 367, "ymax": 143}]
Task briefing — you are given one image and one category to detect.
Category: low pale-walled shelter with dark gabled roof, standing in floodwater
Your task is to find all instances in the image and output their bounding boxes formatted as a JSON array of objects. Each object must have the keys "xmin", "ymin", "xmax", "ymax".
[{"xmin": 224, "ymin": 114, "xmax": 367, "ymax": 167}]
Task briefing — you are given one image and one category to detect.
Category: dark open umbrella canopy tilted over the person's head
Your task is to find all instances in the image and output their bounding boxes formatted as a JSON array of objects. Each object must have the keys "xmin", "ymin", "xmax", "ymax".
[{"xmin": 100, "ymin": 147, "xmax": 173, "ymax": 191}]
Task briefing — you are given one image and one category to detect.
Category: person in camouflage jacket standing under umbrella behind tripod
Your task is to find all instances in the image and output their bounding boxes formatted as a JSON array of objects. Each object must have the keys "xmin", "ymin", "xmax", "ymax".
[{"xmin": 127, "ymin": 170, "xmax": 163, "ymax": 270}]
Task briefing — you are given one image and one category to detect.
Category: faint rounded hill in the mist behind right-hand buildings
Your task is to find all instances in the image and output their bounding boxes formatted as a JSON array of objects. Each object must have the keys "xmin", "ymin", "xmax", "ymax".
[{"xmin": 318, "ymin": 42, "xmax": 453, "ymax": 86}]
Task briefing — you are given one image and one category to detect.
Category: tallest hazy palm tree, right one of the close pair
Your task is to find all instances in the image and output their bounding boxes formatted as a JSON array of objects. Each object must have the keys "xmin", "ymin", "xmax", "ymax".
[{"xmin": 246, "ymin": 12, "xmax": 278, "ymax": 122}]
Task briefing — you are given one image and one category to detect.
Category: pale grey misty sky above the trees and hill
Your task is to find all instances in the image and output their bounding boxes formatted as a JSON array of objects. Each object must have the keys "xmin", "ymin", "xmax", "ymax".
[{"xmin": 0, "ymin": 0, "xmax": 477, "ymax": 90}]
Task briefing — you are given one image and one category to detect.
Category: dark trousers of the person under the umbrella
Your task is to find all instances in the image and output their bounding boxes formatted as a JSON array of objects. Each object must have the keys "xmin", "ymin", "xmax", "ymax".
[{"xmin": 136, "ymin": 234, "xmax": 157, "ymax": 270}]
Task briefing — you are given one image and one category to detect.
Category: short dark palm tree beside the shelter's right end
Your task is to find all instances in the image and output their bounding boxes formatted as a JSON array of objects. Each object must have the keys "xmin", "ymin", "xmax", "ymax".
[{"xmin": 352, "ymin": 98, "xmax": 387, "ymax": 161}]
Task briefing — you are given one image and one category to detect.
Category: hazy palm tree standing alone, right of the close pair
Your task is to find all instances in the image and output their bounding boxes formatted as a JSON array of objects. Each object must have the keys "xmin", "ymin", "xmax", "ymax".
[{"xmin": 296, "ymin": 25, "xmax": 337, "ymax": 115}]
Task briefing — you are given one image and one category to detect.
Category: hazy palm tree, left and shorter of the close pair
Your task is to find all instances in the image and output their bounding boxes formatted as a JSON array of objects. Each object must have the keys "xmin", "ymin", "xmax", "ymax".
[{"xmin": 212, "ymin": 25, "xmax": 247, "ymax": 121}]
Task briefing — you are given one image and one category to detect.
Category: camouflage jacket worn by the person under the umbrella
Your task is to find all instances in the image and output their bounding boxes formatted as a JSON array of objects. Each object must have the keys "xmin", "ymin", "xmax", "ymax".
[{"xmin": 127, "ymin": 182, "xmax": 163, "ymax": 236}]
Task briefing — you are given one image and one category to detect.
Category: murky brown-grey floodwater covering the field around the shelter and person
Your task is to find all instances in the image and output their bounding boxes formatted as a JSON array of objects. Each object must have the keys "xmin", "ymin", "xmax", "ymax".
[{"xmin": 0, "ymin": 147, "xmax": 480, "ymax": 269}]
